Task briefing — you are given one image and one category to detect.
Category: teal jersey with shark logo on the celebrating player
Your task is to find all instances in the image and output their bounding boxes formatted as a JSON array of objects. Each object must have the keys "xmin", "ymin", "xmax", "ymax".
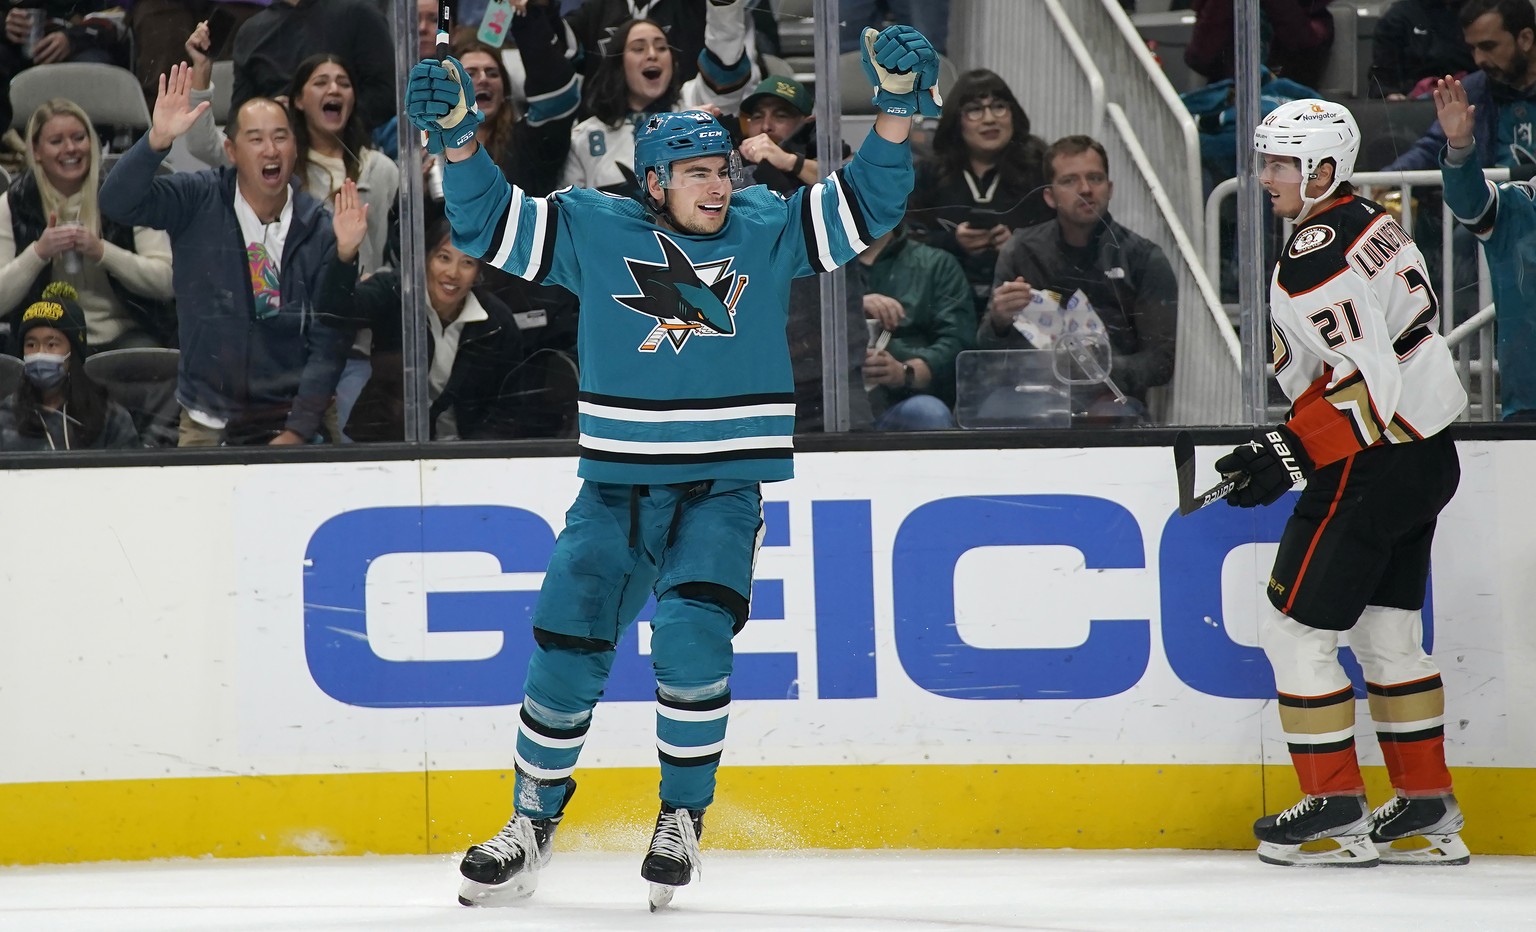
[{"xmin": 444, "ymin": 132, "xmax": 912, "ymax": 484}]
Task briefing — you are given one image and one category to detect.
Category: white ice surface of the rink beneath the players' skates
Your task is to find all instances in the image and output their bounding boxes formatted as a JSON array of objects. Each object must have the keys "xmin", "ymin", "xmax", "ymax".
[{"xmin": 0, "ymin": 851, "xmax": 1536, "ymax": 932}]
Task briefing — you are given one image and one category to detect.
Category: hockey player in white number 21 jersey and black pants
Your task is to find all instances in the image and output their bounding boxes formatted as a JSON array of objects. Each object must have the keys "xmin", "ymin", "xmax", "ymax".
[{"xmin": 1217, "ymin": 100, "xmax": 1468, "ymax": 868}]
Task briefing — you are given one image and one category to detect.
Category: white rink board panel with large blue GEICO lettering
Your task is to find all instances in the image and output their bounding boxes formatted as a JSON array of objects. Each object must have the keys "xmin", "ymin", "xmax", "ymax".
[{"xmin": 0, "ymin": 444, "xmax": 1536, "ymax": 780}]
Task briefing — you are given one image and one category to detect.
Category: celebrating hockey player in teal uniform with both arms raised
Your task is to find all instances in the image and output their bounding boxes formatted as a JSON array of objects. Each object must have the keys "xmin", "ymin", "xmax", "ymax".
[{"xmin": 406, "ymin": 26, "xmax": 942, "ymax": 909}]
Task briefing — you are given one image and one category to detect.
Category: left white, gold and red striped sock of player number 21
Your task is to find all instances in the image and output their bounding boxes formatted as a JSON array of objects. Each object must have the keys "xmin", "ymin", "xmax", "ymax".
[{"xmin": 1260, "ymin": 614, "xmax": 1366, "ymax": 795}]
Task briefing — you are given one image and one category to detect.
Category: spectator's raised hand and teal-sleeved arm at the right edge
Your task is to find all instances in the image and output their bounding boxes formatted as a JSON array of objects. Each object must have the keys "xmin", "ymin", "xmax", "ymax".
[{"xmin": 1435, "ymin": 75, "xmax": 1536, "ymax": 421}]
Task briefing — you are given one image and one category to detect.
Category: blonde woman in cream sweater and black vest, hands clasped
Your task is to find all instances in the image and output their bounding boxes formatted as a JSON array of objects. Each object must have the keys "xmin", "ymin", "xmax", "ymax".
[{"xmin": 0, "ymin": 97, "xmax": 177, "ymax": 352}]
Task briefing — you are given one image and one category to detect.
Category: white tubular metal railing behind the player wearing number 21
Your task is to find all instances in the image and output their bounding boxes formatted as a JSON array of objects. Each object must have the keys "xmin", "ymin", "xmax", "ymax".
[{"xmin": 1203, "ymin": 169, "xmax": 1510, "ymax": 421}]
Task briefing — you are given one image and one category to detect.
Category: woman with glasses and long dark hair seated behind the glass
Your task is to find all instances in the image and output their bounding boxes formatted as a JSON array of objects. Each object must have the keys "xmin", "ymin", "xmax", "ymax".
[{"xmin": 908, "ymin": 69, "xmax": 1052, "ymax": 318}]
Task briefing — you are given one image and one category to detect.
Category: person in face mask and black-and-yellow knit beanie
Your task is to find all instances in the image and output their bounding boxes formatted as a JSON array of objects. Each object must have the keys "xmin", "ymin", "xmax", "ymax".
[{"xmin": 0, "ymin": 283, "xmax": 144, "ymax": 453}]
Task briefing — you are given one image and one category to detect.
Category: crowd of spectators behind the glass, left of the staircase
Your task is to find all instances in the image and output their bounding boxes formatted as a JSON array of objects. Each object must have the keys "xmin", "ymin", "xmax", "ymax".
[{"xmin": 0, "ymin": 0, "xmax": 1198, "ymax": 450}]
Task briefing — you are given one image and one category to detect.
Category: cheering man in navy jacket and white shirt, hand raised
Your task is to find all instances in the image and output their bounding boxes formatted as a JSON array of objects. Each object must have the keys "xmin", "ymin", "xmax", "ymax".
[{"xmin": 101, "ymin": 64, "xmax": 347, "ymax": 447}]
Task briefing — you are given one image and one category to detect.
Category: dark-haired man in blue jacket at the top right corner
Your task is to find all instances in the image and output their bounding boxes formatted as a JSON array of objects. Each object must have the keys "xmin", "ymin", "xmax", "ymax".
[{"xmin": 1385, "ymin": 0, "xmax": 1536, "ymax": 172}]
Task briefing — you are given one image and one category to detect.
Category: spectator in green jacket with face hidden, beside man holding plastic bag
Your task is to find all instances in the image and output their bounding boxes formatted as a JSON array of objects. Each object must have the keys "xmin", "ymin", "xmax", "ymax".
[{"xmin": 859, "ymin": 224, "xmax": 975, "ymax": 430}]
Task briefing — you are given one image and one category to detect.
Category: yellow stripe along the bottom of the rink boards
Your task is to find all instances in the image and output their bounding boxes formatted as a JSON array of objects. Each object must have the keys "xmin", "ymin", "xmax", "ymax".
[{"xmin": 0, "ymin": 765, "xmax": 1536, "ymax": 864}]
